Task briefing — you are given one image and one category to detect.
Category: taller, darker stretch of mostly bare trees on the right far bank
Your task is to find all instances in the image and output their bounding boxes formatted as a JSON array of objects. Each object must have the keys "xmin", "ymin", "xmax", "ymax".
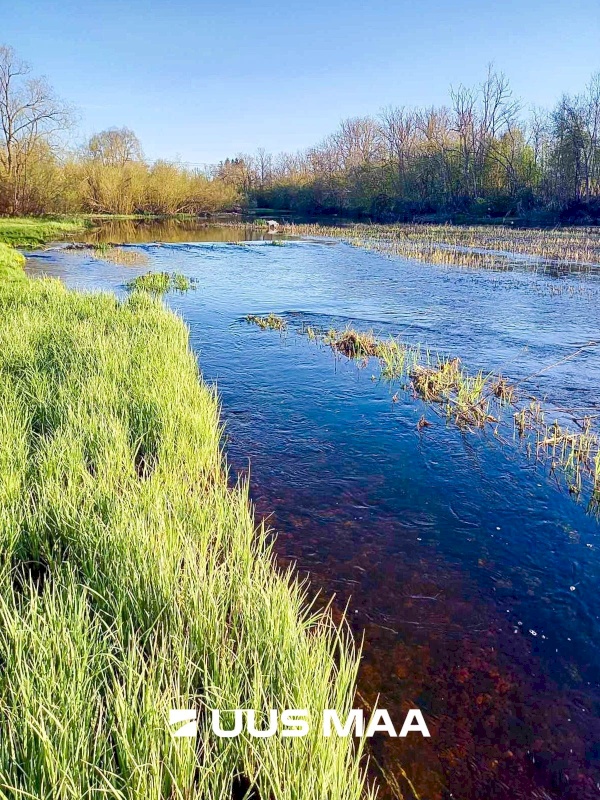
[{"xmin": 218, "ymin": 67, "xmax": 600, "ymax": 222}]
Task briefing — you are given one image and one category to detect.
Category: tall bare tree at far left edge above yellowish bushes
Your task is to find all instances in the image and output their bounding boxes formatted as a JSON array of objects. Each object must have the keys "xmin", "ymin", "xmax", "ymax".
[{"xmin": 0, "ymin": 45, "xmax": 72, "ymax": 214}]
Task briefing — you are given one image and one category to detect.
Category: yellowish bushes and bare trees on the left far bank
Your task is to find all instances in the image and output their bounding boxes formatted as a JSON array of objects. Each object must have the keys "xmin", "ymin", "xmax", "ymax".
[{"xmin": 0, "ymin": 46, "xmax": 242, "ymax": 214}]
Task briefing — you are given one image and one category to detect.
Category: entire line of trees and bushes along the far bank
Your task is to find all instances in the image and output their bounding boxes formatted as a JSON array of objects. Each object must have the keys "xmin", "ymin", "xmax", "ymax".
[{"xmin": 0, "ymin": 41, "xmax": 600, "ymax": 222}]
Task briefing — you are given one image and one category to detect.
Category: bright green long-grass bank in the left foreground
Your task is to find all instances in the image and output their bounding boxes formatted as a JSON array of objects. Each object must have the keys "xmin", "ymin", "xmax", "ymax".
[{"xmin": 0, "ymin": 279, "xmax": 370, "ymax": 800}]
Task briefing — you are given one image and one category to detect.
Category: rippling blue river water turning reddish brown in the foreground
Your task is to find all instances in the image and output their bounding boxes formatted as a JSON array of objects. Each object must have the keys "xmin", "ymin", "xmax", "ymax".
[{"xmin": 28, "ymin": 229, "xmax": 600, "ymax": 800}]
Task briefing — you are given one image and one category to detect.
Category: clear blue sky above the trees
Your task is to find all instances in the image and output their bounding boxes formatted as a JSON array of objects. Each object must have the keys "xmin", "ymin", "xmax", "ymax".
[{"xmin": 0, "ymin": 0, "xmax": 600, "ymax": 163}]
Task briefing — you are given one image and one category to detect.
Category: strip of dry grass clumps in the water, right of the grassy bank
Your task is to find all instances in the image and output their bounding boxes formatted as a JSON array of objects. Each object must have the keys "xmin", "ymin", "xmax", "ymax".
[{"xmin": 288, "ymin": 326, "xmax": 600, "ymax": 509}]
